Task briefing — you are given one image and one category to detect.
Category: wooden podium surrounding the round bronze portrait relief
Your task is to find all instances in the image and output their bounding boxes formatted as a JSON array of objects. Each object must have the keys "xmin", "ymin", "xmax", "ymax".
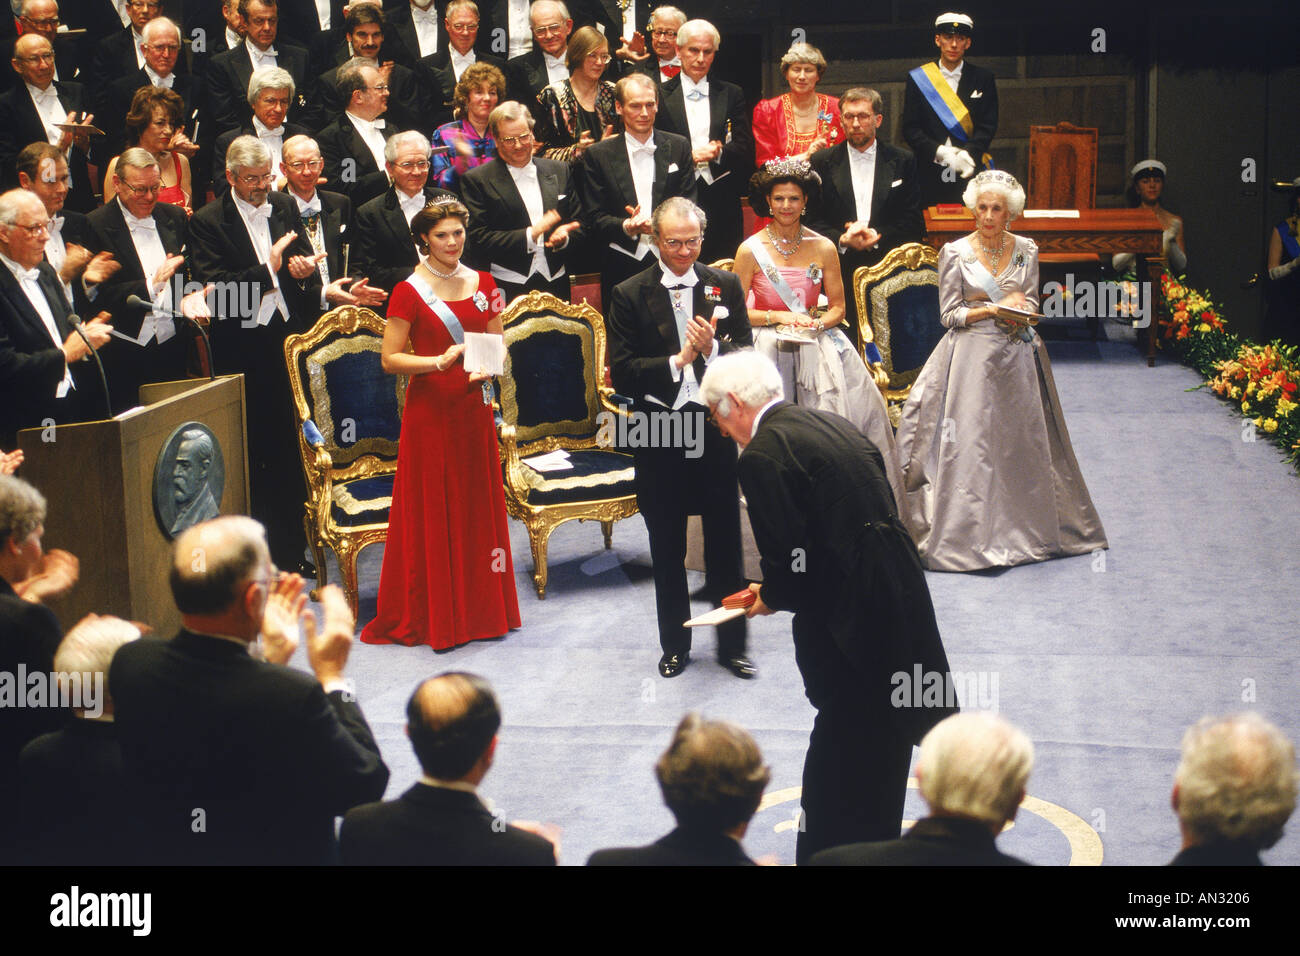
[{"xmin": 18, "ymin": 375, "xmax": 248, "ymax": 636}]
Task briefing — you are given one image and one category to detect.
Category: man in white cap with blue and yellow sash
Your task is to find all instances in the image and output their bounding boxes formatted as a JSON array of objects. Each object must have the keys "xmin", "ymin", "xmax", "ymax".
[{"xmin": 902, "ymin": 13, "xmax": 997, "ymax": 206}]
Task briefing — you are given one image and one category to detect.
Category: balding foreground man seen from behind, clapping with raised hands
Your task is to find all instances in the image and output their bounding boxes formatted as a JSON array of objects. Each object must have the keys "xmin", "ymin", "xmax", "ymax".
[{"xmin": 109, "ymin": 515, "xmax": 389, "ymax": 865}]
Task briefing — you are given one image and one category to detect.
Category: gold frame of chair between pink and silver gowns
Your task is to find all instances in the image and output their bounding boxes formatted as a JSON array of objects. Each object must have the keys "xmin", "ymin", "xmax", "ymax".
[{"xmin": 853, "ymin": 242, "xmax": 939, "ymax": 428}]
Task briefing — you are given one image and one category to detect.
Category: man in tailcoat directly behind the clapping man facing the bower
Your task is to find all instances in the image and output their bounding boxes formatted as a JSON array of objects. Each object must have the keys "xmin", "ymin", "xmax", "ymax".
[{"xmin": 579, "ymin": 73, "xmax": 697, "ymax": 310}]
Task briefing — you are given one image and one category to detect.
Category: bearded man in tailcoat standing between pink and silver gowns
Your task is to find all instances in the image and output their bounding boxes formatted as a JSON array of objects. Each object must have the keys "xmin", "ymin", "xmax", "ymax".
[{"xmin": 807, "ymin": 87, "xmax": 924, "ymax": 343}]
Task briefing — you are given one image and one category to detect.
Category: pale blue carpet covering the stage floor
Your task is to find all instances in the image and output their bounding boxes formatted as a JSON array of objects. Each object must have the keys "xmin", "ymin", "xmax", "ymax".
[{"xmin": 295, "ymin": 333, "xmax": 1300, "ymax": 865}]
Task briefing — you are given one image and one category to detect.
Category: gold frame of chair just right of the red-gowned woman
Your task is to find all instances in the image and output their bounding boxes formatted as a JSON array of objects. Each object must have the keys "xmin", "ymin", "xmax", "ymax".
[{"xmin": 498, "ymin": 291, "xmax": 637, "ymax": 600}]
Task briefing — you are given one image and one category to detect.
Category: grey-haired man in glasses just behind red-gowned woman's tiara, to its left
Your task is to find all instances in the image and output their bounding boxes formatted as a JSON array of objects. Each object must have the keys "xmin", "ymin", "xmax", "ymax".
[{"xmin": 352, "ymin": 130, "xmax": 455, "ymax": 291}]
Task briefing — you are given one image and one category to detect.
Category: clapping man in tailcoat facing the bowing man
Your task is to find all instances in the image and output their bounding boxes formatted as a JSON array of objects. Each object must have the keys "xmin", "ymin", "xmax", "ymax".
[{"xmin": 605, "ymin": 197, "xmax": 755, "ymax": 679}]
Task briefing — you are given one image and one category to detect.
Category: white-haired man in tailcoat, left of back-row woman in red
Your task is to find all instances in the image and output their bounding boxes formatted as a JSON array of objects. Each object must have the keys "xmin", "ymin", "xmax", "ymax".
[{"xmin": 655, "ymin": 20, "xmax": 754, "ymax": 263}]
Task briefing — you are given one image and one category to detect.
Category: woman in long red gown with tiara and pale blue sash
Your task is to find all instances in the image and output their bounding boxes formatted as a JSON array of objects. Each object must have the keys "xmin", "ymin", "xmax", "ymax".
[{"xmin": 361, "ymin": 200, "xmax": 519, "ymax": 650}]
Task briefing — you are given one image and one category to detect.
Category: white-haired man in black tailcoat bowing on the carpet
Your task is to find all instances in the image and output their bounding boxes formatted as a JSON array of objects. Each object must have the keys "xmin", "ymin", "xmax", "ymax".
[{"xmin": 699, "ymin": 351, "xmax": 954, "ymax": 862}]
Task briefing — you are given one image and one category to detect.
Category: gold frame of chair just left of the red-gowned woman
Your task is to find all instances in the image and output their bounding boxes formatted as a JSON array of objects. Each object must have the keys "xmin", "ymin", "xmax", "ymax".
[{"xmin": 285, "ymin": 306, "xmax": 408, "ymax": 614}]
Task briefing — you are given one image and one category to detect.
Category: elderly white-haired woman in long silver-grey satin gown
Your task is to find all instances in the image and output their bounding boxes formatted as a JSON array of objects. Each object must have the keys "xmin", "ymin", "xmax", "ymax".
[{"xmin": 898, "ymin": 170, "xmax": 1108, "ymax": 571}]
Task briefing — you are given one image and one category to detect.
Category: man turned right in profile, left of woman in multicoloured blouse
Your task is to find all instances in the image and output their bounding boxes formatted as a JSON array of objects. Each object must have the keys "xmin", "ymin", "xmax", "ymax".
[{"xmin": 316, "ymin": 57, "xmax": 397, "ymax": 208}]
